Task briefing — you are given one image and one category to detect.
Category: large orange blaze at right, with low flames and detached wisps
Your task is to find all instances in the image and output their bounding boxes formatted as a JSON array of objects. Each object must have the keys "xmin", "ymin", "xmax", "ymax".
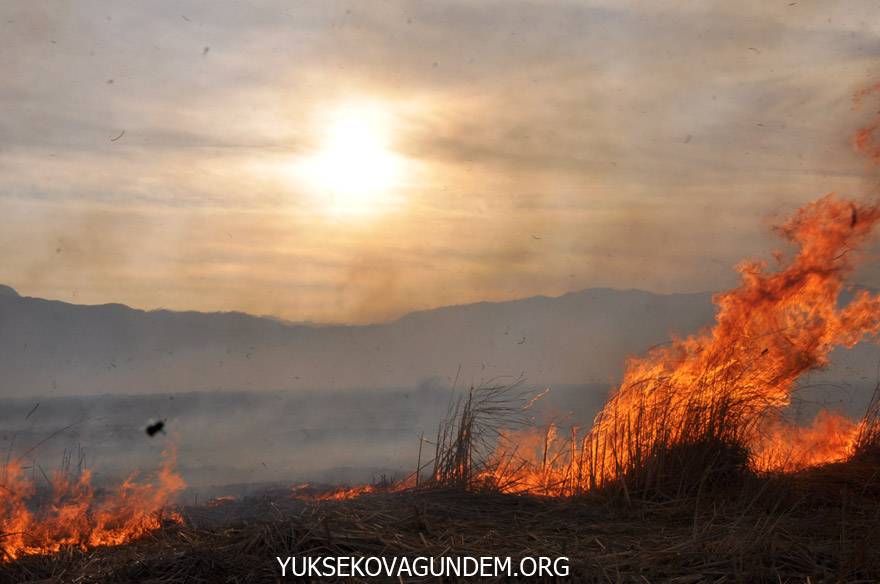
[{"xmin": 480, "ymin": 85, "xmax": 880, "ymax": 495}]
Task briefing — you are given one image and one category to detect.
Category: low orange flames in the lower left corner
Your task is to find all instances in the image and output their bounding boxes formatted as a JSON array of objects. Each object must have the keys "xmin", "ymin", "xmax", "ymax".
[{"xmin": 0, "ymin": 450, "xmax": 185, "ymax": 561}]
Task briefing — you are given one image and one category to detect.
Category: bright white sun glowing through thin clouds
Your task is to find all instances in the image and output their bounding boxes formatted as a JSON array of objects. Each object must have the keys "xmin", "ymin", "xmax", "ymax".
[{"xmin": 303, "ymin": 104, "xmax": 404, "ymax": 215}]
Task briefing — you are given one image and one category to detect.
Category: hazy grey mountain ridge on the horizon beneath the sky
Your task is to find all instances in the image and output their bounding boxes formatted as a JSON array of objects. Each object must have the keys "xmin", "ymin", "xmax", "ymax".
[{"xmin": 0, "ymin": 286, "xmax": 713, "ymax": 397}]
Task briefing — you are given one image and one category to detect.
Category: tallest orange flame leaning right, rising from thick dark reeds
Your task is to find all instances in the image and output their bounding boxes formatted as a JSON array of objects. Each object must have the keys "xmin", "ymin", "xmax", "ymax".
[{"xmin": 591, "ymin": 194, "xmax": 880, "ymax": 479}]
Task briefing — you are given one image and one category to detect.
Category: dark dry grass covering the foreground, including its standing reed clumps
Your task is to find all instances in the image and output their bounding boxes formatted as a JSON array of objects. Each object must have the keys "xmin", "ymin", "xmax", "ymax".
[{"xmin": 0, "ymin": 378, "xmax": 880, "ymax": 584}]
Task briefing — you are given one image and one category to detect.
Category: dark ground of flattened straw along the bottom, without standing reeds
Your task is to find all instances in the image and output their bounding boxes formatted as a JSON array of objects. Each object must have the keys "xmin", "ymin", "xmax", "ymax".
[{"xmin": 0, "ymin": 469, "xmax": 880, "ymax": 584}]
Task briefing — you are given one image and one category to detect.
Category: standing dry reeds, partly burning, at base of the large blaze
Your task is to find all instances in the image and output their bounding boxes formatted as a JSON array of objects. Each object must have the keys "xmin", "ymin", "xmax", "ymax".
[{"xmin": 421, "ymin": 384, "xmax": 757, "ymax": 500}]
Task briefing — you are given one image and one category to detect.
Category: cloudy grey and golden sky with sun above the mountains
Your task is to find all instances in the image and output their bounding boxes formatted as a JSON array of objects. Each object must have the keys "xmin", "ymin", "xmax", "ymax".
[{"xmin": 0, "ymin": 0, "xmax": 880, "ymax": 323}]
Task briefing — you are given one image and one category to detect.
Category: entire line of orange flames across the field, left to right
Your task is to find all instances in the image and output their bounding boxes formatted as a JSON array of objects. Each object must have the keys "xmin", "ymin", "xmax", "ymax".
[{"xmin": 6, "ymin": 85, "xmax": 880, "ymax": 561}]
